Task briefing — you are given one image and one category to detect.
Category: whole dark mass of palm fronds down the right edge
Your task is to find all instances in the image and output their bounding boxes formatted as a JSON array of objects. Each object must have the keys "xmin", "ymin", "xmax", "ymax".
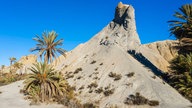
[{"xmin": 166, "ymin": 4, "xmax": 192, "ymax": 102}]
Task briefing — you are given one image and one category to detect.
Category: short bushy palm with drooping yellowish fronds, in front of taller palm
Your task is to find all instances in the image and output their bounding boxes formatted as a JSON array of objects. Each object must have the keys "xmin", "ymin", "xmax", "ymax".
[{"xmin": 24, "ymin": 63, "xmax": 68, "ymax": 102}]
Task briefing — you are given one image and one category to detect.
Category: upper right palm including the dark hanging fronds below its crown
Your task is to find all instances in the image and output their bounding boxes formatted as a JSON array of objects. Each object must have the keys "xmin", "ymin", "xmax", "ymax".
[{"xmin": 168, "ymin": 4, "xmax": 192, "ymax": 53}]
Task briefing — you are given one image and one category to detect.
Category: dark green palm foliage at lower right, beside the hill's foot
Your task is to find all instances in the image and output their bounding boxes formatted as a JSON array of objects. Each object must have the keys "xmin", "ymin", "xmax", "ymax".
[{"xmin": 168, "ymin": 53, "xmax": 192, "ymax": 101}]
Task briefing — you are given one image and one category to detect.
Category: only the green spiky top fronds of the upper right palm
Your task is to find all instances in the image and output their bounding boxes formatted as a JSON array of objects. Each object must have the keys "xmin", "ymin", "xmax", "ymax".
[{"xmin": 168, "ymin": 4, "xmax": 192, "ymax": 39}]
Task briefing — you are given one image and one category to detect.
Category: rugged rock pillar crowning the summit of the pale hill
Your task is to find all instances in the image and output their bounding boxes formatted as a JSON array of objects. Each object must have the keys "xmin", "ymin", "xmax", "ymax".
[{"xmin": 103, "ymin": 2, "xmax": 141, "ymax": 50}]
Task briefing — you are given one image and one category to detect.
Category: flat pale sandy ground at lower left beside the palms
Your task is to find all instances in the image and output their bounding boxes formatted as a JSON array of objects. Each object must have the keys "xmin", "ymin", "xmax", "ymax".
[{"xmin": 0, "ymin": 81, "xmax": 64, "ymax": 108}]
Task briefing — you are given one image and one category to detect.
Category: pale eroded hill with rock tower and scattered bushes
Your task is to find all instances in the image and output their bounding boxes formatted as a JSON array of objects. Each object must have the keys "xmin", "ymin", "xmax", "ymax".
[{"xmin": 57, "ymin": 2, "xmax": 191, "ymax": 108}]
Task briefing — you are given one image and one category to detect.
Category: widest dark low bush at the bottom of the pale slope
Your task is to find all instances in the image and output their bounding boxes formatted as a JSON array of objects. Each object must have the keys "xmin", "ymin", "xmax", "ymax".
[{"xmin": 124, "ymin": 93, "xmax": 159, "ymax": 106}]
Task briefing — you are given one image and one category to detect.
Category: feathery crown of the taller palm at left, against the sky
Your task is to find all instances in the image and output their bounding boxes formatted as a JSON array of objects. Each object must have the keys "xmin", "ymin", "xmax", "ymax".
[{"xmin": 30, "ymin": 31, "xmax": 66, "ymax": 63}]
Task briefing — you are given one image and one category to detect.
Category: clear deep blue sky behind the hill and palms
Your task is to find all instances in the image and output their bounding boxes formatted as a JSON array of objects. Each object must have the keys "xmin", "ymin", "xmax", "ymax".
[{"xmin": 0, "ymin": 0, "xmax": 192, "ymax": 65}]
